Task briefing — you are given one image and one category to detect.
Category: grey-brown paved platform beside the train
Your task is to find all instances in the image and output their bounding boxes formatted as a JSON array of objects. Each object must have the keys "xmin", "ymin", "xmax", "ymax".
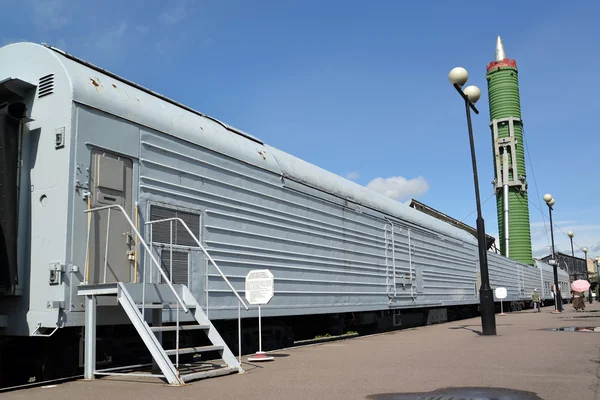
[{"xmin": 0, "ymin": 303, "xmax": 600, "ymax": 400}]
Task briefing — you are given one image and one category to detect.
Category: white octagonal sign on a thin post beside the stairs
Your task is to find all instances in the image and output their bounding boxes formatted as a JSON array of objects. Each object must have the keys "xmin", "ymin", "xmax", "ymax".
[{"xmin": 246, "ymin": 269, "xmax": 274, "ymax": 361}]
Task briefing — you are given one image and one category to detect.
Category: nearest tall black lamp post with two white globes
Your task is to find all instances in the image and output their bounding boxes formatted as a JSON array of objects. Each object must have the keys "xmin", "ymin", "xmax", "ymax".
[{"xmin": 448, "ymin": 67, "xmax": 496, "ymax": 335}]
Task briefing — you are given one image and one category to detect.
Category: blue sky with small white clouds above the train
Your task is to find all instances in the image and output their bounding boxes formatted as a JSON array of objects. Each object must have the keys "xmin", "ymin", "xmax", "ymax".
[{"xmin": 0, "ymin": 0, "xmax": 600, "ymax": 256}]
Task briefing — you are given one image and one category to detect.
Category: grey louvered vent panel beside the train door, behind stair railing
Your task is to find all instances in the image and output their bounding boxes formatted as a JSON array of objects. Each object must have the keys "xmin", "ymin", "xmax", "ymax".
[{"xmin": 150, "ymin": 205, "xmax": 200, "ymax": 247}]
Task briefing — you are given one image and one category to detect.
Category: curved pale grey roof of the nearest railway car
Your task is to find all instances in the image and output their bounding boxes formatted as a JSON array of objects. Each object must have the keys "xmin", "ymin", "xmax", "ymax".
[{"xmin": 0, "ymin": 42, "xmax": 477, "ymax": 244}]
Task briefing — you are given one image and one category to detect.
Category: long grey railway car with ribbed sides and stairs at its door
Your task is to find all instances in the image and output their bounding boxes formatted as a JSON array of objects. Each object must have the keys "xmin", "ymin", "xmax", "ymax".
[{"xmin": 0, "ymin": 43, "xmax": 568, "ymax": 388}]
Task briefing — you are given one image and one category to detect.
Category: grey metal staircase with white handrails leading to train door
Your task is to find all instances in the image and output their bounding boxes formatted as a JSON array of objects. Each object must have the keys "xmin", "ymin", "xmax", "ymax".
[{"xmin": 78, "ymin": 205, "xmax": 248, "ymax": 385}]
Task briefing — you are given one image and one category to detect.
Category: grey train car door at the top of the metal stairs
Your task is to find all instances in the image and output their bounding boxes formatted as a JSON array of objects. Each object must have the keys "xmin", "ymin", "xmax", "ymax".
[{"xmin": 88, "ymin": 149, "xmax": 135, "ymax": 283}]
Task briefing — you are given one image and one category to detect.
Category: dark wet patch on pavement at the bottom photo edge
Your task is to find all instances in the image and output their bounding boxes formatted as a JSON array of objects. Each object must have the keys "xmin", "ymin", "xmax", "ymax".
[{"xmin": 367, "ymin": 387, "xmax": 543, "ymax": 400}]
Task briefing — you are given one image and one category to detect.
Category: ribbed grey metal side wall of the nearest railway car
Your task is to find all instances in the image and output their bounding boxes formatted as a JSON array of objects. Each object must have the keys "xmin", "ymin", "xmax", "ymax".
[{"xmin": 140, "ymin": 128, "xmax": 486, "ymax": 318}]
